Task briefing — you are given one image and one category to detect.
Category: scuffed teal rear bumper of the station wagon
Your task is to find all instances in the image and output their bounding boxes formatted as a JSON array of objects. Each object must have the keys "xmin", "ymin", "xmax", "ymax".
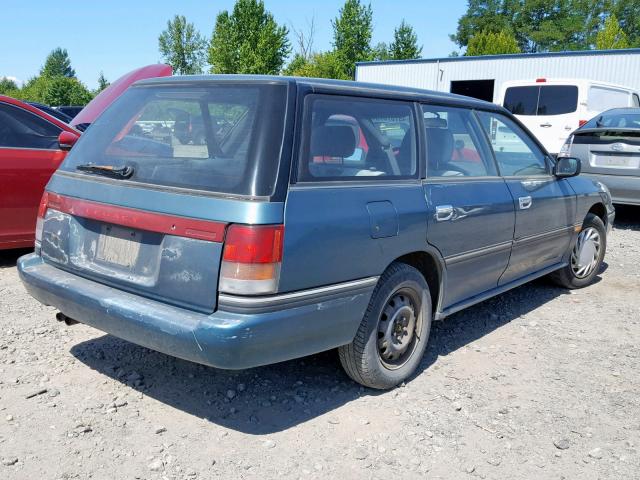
[{"xmin": 18, "ymin": 254, "xmax": 376, "ymax": 369}]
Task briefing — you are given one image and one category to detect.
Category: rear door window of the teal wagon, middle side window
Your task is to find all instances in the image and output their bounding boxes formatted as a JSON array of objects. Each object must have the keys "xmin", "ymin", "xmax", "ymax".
[{"xmin": 422, "ymin": 105, "xmax": 496, "ymax": 177}]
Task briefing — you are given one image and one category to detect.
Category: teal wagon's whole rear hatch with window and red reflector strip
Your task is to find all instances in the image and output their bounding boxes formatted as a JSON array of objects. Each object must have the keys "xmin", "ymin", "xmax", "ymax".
[{"xmin": 37, "ymin": 82, "xmax": 288, "ymax": 312}]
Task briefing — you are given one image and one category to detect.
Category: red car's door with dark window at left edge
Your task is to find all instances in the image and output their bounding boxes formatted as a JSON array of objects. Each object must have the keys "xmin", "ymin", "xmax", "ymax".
[{"xmin": 0, "ymin": 101, "xmax": 66, "ymax": 249}]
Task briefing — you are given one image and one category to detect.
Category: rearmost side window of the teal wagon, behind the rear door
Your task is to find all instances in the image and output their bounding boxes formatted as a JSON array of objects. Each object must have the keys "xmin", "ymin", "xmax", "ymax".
[{"xmin": 298, "ymin": 95, "xmax": 418, "ymax": 182}]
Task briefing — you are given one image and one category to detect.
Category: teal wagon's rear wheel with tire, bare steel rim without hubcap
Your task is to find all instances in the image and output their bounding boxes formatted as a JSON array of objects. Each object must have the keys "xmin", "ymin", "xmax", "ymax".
[{"xmin": 338, "ymin": 263, "xmax": 432, "ymax": 389}]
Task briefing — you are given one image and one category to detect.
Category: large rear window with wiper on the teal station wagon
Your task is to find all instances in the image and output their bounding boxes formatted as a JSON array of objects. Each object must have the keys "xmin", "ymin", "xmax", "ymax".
[{"xmin": 61, "ymin": 83, "xmax": 286, "ymax": 196}]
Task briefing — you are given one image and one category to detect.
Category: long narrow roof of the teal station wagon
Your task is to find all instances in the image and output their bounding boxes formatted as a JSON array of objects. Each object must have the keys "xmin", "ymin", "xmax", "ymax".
[{"xmin": 135, "ymin": 75, "xmax": 506, "ymax": 112}]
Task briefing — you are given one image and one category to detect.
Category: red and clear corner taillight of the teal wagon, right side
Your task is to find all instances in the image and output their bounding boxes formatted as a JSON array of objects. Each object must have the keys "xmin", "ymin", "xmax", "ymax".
[{"xmin": 219, "ymin": 225, "xmax": 284, "ymax": 295}]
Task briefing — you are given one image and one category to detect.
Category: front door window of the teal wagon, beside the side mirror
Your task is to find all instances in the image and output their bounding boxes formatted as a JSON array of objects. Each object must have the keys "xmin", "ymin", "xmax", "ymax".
[{"xmin": 478, "ymin": 112, "xmax": 548, "ymax": 176}]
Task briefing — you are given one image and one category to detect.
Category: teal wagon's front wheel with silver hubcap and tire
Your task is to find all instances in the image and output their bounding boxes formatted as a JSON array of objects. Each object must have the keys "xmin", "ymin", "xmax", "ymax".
[{"xmin": 549, "ymin": 213, "xmax": 607, "ymax": 289}]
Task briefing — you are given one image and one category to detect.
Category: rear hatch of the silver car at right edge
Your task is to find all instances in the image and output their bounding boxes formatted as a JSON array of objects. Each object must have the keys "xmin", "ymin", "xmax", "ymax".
[{"xmin": 572, "ymin": 128, "xmax": 640, "ymax": 176}]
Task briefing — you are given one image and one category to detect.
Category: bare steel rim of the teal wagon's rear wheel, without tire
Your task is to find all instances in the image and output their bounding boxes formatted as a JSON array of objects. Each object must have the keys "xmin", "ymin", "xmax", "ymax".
[{"xmin": 378, "ymin": 289, "xmax": 422, "ymax": 369}]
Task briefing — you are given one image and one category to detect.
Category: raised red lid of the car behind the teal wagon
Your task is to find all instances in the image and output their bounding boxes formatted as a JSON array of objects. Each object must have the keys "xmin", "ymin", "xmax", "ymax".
[{"xmin": 71, "ymin": 63, "xmax": 173, "ymax": 127}]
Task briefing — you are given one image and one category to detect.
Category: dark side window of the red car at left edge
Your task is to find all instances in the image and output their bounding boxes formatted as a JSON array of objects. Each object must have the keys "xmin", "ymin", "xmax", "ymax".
[{"xmin": 0, "ymin": 103, "xmax": 62, "ymax": 150}]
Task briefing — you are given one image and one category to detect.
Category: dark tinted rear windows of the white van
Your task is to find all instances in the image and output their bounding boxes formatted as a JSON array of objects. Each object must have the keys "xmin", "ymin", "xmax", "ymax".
[{"xmin": 504, "ymin": 85, "xmax": 578, "ymax": 116}]
